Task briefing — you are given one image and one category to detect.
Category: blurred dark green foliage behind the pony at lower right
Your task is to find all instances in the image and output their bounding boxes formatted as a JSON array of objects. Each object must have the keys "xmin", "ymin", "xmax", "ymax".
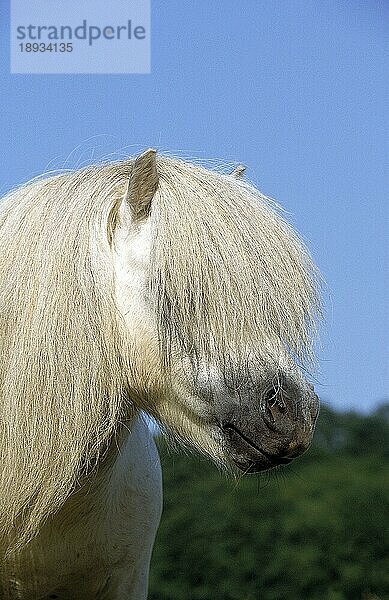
[{"xmin": 149, "ymin": 405, "xmax": 389, "ymax": 600}]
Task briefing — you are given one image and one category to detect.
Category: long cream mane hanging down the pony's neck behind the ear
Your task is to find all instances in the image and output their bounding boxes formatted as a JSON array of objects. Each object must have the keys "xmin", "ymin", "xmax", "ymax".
[{"xmin": 0, "ymin": 165, "xmax": 128, "ymax": 546}]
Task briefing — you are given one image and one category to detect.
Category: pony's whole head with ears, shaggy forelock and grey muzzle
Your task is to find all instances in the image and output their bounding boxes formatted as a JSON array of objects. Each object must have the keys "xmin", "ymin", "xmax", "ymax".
[{"xmin": 112, "ymin": 150, "xmax": 320, "ymax": 472}]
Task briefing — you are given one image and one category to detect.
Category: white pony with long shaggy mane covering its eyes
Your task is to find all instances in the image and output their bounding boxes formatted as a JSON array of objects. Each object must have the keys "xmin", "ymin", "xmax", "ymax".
[{"xmin": 0, "ymin": 149, "xmax": 320, "ymax": 600}]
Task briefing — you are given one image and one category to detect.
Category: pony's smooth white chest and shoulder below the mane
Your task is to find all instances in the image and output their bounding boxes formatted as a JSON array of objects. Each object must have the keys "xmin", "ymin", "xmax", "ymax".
[{"xmin": 0, "ymin": 417, "xmax": 162, "ymax": 600}]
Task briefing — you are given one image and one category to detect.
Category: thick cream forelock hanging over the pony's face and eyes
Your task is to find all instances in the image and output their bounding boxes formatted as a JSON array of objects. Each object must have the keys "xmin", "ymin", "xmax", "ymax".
[{"xmin": 151, "ymin": 159, "xmax": 320, "ymax": 380}]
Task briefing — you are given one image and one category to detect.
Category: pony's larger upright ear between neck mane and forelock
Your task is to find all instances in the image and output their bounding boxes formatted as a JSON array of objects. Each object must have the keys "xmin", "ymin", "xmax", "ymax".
[{"xmin": 124, "ymin": 148, "xmax": 159, "ymax": 221}]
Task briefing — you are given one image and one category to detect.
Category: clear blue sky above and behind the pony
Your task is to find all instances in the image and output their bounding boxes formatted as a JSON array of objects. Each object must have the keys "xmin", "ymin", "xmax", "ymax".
[{"xmin": 0, "ymin": 0, "xmax": 389, "ymax": 410}]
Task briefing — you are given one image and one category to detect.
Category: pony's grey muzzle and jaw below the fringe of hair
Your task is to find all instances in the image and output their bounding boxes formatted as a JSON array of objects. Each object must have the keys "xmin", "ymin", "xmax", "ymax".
[{"xmin": 145, "ymin": 352, "xmax": 319, "ymax": 473}]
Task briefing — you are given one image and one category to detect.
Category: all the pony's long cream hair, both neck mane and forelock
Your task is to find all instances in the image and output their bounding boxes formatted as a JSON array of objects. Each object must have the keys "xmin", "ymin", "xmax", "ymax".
[{"xmin": 0, "ymin": 157, "xmax": 318, "ymax": 547}]
